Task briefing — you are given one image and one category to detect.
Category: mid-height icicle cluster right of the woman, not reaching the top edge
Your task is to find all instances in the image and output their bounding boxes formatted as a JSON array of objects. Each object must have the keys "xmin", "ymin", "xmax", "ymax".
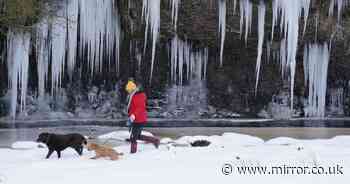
[{"xmin": 170, "ymin": 36, "xmax": 208, "ymax": 86}]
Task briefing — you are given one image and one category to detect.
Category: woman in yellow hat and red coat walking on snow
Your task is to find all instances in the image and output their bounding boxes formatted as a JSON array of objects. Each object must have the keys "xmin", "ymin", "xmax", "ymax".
[{"xmin": 125, "ymin": 79, "xmax": 160, "ymax": 153}]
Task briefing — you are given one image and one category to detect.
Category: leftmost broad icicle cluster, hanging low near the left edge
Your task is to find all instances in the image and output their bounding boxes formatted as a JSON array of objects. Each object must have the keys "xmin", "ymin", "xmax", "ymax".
[{"xmin": 7, "ymin": 30, "xmax": 30, "ymax": 119}]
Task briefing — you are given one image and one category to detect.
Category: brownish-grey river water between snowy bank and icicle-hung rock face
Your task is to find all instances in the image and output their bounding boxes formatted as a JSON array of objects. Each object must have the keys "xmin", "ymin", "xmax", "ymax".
[{"xmin": 0, "ymin": 126, "xmax": 350, "ymax": 148}]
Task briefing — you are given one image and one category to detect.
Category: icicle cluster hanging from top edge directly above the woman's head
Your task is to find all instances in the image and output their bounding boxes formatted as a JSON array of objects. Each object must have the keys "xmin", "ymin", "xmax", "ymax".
[{"xmin": 142, "ymin": 0, "xmax": 160, "ymax": 82}]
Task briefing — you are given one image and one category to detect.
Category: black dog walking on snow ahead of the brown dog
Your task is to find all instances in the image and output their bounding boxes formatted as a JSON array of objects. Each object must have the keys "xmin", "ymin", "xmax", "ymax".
[{"xmin": 36, "ymin": 133, "xmax": 87, "ymax": 159}]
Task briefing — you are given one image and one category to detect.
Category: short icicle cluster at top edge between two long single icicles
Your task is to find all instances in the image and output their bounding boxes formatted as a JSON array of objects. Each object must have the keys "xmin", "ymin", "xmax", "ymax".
[{"xmin": 240, "ymin": 0, "xmax": 253, "ymax": 43}]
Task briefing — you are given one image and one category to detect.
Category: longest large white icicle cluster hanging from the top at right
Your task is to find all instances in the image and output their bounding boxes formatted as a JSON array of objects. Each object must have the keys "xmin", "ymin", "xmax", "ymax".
[{"xmin": 272, "ymin": 0, "xmax": 310, "ymax": 109}]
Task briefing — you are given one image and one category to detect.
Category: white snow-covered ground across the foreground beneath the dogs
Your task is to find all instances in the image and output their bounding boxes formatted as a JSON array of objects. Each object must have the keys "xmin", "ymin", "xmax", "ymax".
[{"xmin": 0, "ymin": 132, "xmax": 350, "ymax": 184}]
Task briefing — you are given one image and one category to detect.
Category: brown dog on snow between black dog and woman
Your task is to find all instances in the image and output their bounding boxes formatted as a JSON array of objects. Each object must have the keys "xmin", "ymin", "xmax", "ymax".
[{"xmin": 87, "ymin": 143, "xmax": 124, "ymax": 160}]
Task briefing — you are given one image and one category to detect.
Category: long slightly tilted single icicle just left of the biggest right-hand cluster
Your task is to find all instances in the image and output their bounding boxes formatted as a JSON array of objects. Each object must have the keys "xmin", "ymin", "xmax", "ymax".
[{"xmin": 255, "ymin": 1, "xmax": 266, "ymax": 94}]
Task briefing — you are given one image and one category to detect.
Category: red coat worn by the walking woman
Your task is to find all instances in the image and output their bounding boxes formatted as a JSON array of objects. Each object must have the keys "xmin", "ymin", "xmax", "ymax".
[{"xmin": 128, "ymin": 92, "xmax": 147, "ymax": 123}]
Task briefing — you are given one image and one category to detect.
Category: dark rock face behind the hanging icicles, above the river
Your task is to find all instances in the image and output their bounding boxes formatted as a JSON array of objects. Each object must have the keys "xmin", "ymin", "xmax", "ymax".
[{"xmin": 0, "ymin": 0, "xmax": 350, "ymax": 119}]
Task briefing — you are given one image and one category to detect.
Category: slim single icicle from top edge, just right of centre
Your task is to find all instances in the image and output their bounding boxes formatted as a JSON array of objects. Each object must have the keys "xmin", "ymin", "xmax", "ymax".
[{"xmin": 218, "ymin": 0, "xmax": 226, "ymax": 66}]
